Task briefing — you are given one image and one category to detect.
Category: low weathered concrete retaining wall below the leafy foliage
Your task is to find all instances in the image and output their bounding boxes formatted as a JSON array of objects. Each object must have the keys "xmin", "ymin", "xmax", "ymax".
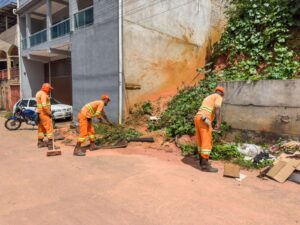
[{"xmin": 222, "ymin": 80, "xmax": 300, "ymax": 137}]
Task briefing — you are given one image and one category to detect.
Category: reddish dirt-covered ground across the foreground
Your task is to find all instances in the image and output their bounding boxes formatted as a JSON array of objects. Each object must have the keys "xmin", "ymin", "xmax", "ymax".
[{"xmin": 0, "ymin": 118, "xmax": 300, "ymax": 225}]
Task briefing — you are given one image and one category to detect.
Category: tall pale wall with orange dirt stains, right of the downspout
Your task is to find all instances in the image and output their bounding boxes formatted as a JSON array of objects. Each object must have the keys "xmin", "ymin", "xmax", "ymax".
[{"xmin": 124, "ymin": 0, "xmax": 224, "ymax": 112}]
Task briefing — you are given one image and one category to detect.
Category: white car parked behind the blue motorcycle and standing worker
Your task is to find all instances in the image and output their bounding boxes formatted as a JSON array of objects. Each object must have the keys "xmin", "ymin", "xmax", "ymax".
[{"xmin": 13, "ymin": 98, "xmax": 72, "ymax": 120}]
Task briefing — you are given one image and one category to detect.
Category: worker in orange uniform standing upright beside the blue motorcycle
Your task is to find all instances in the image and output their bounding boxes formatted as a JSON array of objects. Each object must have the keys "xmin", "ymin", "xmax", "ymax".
[{"xmin": 36, "ymin": 83, "xmax": 54, "ymax": 150}]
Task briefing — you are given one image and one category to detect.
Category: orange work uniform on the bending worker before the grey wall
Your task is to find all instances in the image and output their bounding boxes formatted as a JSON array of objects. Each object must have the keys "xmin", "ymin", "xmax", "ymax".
[{"xmin": 77, "ymin": 100, "xmax": 105, "ymax": 143}]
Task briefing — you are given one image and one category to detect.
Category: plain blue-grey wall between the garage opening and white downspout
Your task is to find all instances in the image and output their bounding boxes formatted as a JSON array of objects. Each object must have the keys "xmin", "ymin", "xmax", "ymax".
[{"xmin": 71, "ymin": 0, "xmax": 119, "ymax": 122}]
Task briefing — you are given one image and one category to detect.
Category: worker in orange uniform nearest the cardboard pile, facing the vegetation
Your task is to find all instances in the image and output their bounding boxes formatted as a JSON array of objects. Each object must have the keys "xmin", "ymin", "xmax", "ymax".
[{"xmin": 194, "ymin": 87, "xmax": 224, "ymax": 172}]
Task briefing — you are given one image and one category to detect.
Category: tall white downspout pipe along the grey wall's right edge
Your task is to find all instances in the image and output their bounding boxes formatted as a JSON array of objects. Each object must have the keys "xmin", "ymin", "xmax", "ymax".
[{"xmin": 118, "ymin": 0, "xmax": 124, "ymax": 124}]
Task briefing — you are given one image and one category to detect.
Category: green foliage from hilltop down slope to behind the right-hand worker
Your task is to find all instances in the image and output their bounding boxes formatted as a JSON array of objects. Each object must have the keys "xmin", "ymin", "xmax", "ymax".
[{"xmin": 149, "ymin": 0, "xmax": 300, "ymax": 137}]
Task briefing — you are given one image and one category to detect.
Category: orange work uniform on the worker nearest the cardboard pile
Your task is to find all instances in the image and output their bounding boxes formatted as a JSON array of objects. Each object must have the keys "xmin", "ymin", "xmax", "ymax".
[{"xmin": 194, "ymin": 93, "xmax": 223, "ymax": 159}]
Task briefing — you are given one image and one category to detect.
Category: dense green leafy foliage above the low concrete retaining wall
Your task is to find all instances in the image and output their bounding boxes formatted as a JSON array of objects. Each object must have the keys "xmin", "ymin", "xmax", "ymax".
[{"xmin": 213, "ymin": 0, "xmax": 300, "ymax": 80}]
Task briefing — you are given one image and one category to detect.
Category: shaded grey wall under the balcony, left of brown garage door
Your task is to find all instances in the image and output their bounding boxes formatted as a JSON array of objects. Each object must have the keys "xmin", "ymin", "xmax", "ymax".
[{"xmin": 20, "ymin": 57, "xmax": 44, "ymax": 98}]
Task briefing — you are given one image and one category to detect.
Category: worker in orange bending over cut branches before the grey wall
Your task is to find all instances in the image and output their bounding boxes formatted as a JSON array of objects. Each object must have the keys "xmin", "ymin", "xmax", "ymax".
[{"xmin": 73, "ymin": 95, "xmax": 112, "ymax": 156}]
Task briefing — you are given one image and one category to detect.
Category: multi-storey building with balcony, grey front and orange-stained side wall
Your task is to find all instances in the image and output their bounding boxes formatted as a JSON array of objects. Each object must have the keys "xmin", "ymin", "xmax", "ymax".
[{"xmin": 17, "ymin": 0, "xmax": 224, "ymax": 121}]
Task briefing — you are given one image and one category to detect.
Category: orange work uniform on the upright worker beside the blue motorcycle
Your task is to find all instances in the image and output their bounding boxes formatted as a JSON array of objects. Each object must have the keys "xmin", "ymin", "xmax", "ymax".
[{"xmin": 36, "ymin": 90, "xmax": 53, "ymax": 140}]
